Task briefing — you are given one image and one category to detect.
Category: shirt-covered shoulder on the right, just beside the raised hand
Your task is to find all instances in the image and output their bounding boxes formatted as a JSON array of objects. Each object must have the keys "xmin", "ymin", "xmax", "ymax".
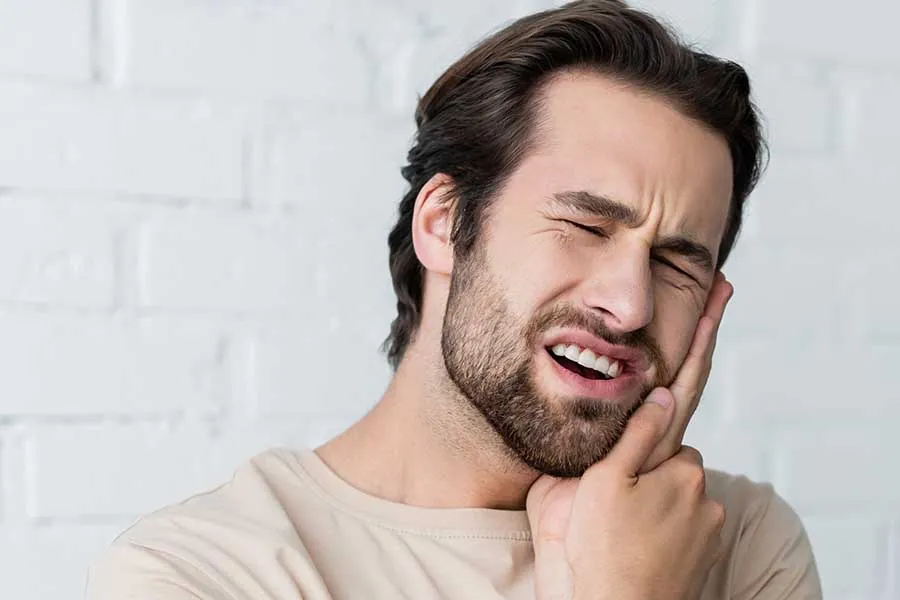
[{"xmin": 706, "ymin": 469, "xmax": 822, "ymax": 600}]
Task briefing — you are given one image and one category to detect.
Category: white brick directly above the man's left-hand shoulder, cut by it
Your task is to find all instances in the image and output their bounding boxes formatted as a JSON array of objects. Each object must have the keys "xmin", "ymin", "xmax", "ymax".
[{"xmin": 28, "ymin": 419, "xmax": 324, "ymax": 521}]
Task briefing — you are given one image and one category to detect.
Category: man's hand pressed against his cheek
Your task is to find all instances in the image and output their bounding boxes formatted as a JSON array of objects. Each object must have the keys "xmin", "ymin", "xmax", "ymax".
[{"xmin": 527, "ymin": 273, "xmax": 732, "ymax": 600}]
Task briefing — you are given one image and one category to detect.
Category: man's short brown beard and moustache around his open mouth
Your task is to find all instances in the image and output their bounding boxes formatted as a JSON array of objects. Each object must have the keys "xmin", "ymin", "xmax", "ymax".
[{"xmin": 441, "ymin": 244, "xmax": 669, "ymax": 477}]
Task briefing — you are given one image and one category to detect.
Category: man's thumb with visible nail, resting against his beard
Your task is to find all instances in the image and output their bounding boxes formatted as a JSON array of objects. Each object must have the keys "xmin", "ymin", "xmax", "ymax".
[{"xmin": 602, "ymin": 387, "xmax": 675, "ymax": 476}]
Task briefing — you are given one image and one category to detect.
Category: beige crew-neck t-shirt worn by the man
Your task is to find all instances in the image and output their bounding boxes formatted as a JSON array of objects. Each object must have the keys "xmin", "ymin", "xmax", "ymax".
[{"xmin": 87, "ymin": 449, "xmax": 822, "ymax": 600}]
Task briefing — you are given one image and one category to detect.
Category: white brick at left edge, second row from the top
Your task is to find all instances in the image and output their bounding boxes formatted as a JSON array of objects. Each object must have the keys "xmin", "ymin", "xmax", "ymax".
[{"xmin": 0, "ymin": 84, "xmax": 243, "ymax": 201}]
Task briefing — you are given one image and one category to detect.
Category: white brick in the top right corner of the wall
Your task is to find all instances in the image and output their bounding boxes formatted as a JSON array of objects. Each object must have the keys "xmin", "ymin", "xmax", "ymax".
[{"xmin": 757, "ymin": 0, "xmax": 900, "ymax": 64}]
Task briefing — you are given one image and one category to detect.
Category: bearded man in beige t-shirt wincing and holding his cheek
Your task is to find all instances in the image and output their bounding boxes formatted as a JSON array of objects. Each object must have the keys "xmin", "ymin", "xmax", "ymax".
[{"xmin": 89, "ymin": 0, "xmax": 821, "ymax": 600}]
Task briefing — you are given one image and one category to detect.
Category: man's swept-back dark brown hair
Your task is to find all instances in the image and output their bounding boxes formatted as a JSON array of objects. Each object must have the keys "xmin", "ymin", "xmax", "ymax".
[{"xmin": 384, "ymin": 0, "xmax": 765, "ymax": 369}]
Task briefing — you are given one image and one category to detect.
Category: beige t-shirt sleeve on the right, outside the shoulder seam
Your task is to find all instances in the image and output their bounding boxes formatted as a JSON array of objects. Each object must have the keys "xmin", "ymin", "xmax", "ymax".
[{"xmin": 732, "ymin": 484, "xmax": 822, "ymax": 600}]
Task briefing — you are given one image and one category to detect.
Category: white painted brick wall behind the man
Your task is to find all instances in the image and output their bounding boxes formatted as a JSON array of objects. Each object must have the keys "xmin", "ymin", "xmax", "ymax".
[{"xmin": 0, "ymin": 0, "xmax": 900, "ymax": 600}]
